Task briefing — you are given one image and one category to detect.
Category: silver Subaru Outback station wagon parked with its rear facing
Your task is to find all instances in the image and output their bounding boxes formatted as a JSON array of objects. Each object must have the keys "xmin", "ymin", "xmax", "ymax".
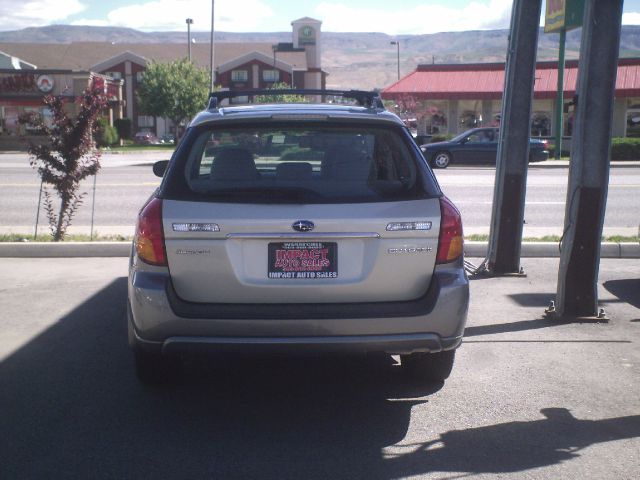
[{"xmin": 127, "ymin": 91, "xmax": 469, "ymax": 383}]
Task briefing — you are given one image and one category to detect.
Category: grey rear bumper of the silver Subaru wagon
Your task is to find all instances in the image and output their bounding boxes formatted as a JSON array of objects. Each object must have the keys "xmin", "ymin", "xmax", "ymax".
[{"xmin": 128, "ymin": 262, "xmax": 469, "ymax": 354}]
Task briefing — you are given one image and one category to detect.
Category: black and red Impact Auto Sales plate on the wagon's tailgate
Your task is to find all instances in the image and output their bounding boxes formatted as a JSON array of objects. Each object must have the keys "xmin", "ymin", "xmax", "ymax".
[{"xmin": 268, "ymin": 242, "xmax": 338, "ymax": 279}]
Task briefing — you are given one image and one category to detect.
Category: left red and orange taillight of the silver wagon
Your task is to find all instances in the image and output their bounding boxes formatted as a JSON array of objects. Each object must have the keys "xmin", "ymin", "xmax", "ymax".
[{"xmin": 135, "ymin": 198, "xmax": 167, "ymax": 266}]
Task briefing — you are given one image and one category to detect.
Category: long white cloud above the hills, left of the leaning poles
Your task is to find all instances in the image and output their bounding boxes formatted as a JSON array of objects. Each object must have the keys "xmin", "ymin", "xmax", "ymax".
[{"xmin": 315, "ymin": 0, "xmax": 513, "ymax": 34}]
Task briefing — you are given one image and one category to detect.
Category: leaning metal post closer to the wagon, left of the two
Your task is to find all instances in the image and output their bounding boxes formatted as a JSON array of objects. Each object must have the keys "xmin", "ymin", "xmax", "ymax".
[{"xmin": 487, "ymin": 0, "xmax": 542, "ymax": 275}]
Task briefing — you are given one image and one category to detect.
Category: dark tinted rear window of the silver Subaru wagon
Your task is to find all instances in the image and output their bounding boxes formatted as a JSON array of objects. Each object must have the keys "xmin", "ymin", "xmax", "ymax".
[{"xmin": 175, "ymin": 125, "xmax": 428, "ymax": 203}]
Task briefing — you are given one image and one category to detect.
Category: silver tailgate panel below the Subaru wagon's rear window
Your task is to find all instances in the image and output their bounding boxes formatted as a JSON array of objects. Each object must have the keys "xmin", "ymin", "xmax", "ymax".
[{"xmin": 163, "ymin": 199, "xmax": 440, "ymax": 303}]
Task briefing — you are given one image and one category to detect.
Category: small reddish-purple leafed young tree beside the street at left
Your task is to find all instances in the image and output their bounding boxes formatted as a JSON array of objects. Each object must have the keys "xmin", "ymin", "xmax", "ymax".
[{"xmin": 20, "ymin": 88, "xmax": 107, "ymax": 242}]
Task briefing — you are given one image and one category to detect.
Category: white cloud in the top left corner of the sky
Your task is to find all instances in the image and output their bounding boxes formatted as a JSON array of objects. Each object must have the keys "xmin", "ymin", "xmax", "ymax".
[{"xmin": 0, "ymin": 0, "xmax": 87, "ymax": 30}]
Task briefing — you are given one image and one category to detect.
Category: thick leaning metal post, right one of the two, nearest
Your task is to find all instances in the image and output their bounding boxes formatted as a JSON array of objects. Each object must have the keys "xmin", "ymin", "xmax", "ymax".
[{"xmin": 550, "ymin": 0, "xmax": 622, "ymax": 317}]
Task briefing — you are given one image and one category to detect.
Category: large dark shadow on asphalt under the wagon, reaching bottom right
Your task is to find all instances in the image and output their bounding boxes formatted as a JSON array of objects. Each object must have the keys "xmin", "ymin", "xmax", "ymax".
[{"xmin": 0, "ymin": 278, "xmax": 640, "ymax": 479}]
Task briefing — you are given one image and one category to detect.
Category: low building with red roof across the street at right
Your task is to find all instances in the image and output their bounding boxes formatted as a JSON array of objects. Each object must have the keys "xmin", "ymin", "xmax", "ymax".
[{"xmin": 382, "ymin": 58, "xmax": 640, "ymax": 137}]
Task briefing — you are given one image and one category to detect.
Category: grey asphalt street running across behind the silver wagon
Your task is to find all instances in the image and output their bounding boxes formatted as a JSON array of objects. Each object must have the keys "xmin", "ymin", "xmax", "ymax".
[{"xmin": 0, "ymin": 152, "xmax": 640, "ymax": 237}]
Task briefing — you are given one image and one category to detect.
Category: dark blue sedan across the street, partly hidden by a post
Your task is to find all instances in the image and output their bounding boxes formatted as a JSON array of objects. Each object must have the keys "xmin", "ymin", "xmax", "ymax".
[{"xmin": 420, "ymin": 127, "xmax": 549, "ymax": 168}]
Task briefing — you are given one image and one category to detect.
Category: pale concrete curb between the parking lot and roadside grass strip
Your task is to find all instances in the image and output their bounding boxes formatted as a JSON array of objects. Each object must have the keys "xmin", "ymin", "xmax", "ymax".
[{"xmin": 0, "ymin": 242, "xmax": 640, "ymax": 258}]
